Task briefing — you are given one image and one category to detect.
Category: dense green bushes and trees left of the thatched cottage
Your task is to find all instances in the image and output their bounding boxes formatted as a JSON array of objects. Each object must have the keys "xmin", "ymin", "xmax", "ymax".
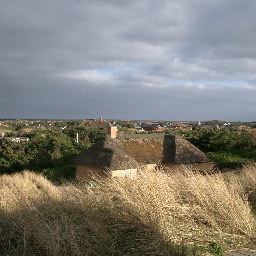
[{"xmin": 0, "ymin": 125, "xmax": 106, "ymax": 179}]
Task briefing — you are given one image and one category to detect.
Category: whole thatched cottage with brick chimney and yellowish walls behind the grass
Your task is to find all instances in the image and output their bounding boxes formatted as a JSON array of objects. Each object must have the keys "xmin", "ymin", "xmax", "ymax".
[{"xmin": 74, "ymin": 127, "xmax": 213, "ymax": 179}]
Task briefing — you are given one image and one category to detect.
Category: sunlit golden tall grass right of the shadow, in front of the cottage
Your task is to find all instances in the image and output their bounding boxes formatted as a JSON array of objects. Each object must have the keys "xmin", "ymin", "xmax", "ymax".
[{"xmin": 102, "ymin": 167, "xmax": 256, "ymax": 247}]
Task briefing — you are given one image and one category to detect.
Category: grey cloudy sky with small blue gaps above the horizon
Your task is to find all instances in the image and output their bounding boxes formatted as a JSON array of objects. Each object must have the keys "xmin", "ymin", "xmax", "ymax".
[{"xmin": 0, "ymin": 0, "xmax": 256, "ymax": 122}]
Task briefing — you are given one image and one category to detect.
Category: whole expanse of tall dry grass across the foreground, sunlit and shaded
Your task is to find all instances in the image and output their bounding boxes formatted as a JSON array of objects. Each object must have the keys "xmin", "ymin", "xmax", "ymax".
[{"xmin": 0, "ymin": 166, "xmax": 256, "ymax": 255}]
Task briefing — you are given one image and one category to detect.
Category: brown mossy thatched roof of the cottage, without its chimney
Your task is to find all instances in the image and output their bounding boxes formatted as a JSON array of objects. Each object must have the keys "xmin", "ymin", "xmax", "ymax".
[{"xmin": 74, "ymin": 134, "xmax": 209, "ymax": 170}]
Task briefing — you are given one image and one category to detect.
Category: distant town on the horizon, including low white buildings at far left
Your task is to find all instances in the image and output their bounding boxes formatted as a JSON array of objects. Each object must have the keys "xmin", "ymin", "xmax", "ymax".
[{"xmin": 0, "ymin": 117, "xmax": 256, "ymax": 146}]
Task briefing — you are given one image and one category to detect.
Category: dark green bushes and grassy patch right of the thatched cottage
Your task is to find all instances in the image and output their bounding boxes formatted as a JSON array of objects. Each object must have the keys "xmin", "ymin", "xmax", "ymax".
[{"xmin": 185, "ymin": 129, "xmax": 256, "ymax": 168}]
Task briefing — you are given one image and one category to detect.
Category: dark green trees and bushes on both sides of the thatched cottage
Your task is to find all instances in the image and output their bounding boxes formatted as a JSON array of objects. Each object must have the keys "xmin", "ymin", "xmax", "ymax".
[{"xmin": 0, "ymin": 122, "xmax": 256, "ymax": 180}]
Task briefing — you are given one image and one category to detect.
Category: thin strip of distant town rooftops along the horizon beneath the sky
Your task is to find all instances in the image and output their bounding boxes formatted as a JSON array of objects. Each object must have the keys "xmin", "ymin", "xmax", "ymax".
[{"xmin": 0, "ymin": 117, "xmax": 256, "ymax": 137}]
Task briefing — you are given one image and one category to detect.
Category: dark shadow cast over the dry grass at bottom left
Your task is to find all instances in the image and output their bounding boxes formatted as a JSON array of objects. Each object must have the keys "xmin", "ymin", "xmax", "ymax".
[{"xmin": 0, "ymin": 197, "xmax": 202, "ymax": 256}]
